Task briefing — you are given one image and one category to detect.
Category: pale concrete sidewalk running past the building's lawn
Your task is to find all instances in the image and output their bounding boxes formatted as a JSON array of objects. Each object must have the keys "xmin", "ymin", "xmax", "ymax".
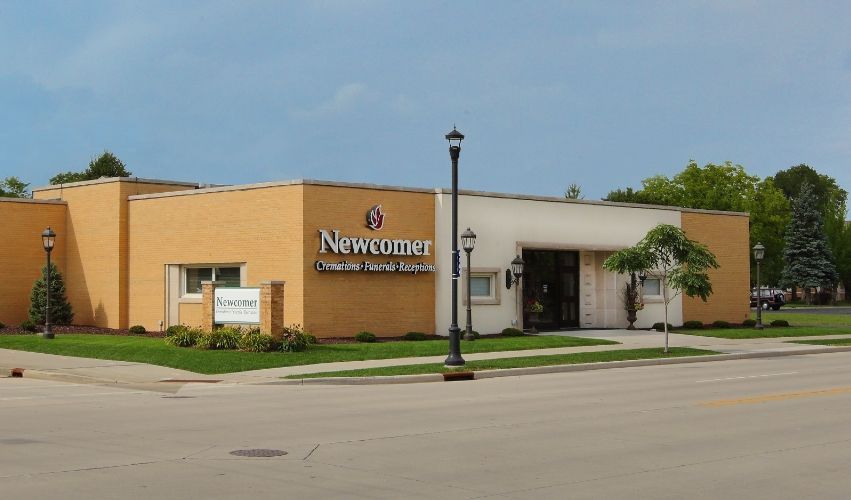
[{"xmin": 0, "ymin": 330, "xmax": 851, "ymax": 387}]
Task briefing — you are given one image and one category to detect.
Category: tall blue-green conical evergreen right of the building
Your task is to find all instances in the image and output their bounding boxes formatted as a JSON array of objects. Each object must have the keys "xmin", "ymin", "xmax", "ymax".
[{"xmin": 781, "ymin": 181, "xmax": 839, "ymax": 303}]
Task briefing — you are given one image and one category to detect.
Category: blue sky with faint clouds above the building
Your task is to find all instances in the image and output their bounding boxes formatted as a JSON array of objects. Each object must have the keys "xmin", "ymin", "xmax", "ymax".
[{"xmin": 0, "ymin": 0, "xmax": 851, "ymax": 199}]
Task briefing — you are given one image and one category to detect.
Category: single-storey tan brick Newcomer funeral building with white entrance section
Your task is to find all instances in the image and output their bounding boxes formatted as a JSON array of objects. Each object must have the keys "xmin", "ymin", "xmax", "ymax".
[{"xmin": 0, "ymin": 178, "xmax": 749, "ymax": 337}]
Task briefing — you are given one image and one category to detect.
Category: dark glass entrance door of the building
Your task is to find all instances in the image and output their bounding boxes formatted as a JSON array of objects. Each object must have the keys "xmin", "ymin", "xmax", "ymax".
[{"xmin": 523, "ymin": 250, "xmax": 579, "ymax": 330}]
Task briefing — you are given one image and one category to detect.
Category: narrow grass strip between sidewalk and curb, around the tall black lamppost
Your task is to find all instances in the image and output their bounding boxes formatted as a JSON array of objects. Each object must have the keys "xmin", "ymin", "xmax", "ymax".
[{"xmin": 285, "ymin": 347, "xmax": 718, "ymax": 379}]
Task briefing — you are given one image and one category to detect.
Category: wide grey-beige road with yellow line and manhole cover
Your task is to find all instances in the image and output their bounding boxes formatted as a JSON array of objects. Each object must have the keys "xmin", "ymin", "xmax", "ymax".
[{"xmin": 0, "ymin": 353, "xmax": 851, "ymax": 500}]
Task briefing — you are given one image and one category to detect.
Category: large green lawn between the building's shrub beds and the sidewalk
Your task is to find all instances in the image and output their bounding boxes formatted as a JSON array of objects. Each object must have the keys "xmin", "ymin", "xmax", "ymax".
[{"xmin": 0, "ymin": 335, "xmax": 618, "ymax": 374}]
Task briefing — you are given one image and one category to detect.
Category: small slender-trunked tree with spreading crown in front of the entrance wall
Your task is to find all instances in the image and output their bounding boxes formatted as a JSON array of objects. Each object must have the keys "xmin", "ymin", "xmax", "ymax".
[{"xmin": 603, "ymin": 224, "xmax": 718, "ymax": 353}]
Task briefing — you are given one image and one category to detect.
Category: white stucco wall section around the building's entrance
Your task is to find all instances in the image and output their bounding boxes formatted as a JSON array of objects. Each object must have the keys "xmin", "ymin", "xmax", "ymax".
[{"xmin": 435, "ymin": 191, "xmax": 682, "ymax": 335}]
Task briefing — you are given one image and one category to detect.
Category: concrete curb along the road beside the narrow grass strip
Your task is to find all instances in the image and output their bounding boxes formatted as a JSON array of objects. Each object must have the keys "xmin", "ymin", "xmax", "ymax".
[{"xmin": 274, "ymin": 346, "xmax": 851, "ymax": 385}]
